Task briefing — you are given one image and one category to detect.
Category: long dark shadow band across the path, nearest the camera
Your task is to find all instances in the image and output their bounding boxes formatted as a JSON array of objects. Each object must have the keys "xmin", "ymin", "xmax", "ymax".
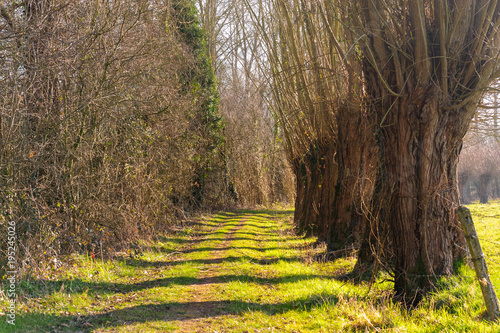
[{"xmin": 10, "ymin": 293, "xmax": 338, "ymax": 332}]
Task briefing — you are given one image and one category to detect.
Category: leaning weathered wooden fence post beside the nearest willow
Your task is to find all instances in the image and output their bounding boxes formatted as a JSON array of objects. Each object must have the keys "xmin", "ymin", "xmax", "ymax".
[{"xmin": 458, "ymin": 206, "xmax": 500, "ymax": 320}]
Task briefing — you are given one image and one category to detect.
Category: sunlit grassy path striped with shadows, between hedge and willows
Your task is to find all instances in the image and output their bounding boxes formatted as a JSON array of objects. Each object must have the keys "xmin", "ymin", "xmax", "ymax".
[{"xmin": 9, "ymin": 210, "xmax": 344, "ymax": 333}]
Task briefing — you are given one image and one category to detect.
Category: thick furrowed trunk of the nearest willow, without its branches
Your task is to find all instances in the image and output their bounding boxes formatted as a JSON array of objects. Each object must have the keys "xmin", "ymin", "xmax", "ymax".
[{"xmin": 375, "ymin": 92, "xmax": 468, "ymax": 304}]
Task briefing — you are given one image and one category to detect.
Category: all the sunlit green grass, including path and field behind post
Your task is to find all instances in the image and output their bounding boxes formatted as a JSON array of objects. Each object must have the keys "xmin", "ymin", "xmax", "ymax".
[{"xmin": 0, "ymin": 203, "xmax": 500, "ymax": 333}]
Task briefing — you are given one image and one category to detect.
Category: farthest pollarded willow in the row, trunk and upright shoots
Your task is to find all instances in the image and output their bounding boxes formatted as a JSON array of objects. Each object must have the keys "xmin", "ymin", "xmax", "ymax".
[{"xmin": 247, "ymin": 0, "xmax": 338, "ymax": 240}]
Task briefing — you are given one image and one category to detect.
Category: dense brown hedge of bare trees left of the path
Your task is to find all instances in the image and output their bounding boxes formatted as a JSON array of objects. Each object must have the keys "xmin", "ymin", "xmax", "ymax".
[{"xmin": 0, "ymin": 0, "xmax": 235, "ymax": 267}]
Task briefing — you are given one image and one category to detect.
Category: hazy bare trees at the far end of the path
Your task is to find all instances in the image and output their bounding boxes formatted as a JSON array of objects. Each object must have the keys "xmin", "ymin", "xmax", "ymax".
[{"xmin": 198, "ymin": 0, "xmax": 294, "ymax": 206}]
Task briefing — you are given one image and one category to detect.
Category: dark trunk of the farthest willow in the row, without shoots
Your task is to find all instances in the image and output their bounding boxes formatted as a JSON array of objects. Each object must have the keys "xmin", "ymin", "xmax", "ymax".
[{"xmin": 293, "ymin": 140, "xmax": 337, "ymax": 241}]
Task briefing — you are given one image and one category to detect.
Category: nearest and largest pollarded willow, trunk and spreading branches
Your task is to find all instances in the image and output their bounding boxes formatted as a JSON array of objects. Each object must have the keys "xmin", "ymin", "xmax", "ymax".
[{"xmin": 346, "ymin": 0, "xmax": 500, "ymax": 302}]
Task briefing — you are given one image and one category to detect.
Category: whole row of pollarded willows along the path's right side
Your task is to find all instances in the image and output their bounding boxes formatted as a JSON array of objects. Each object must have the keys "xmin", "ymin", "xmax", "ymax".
[{"xmin": 235, "ymin": 0, "xmax": 500, "ymax": 304}]
